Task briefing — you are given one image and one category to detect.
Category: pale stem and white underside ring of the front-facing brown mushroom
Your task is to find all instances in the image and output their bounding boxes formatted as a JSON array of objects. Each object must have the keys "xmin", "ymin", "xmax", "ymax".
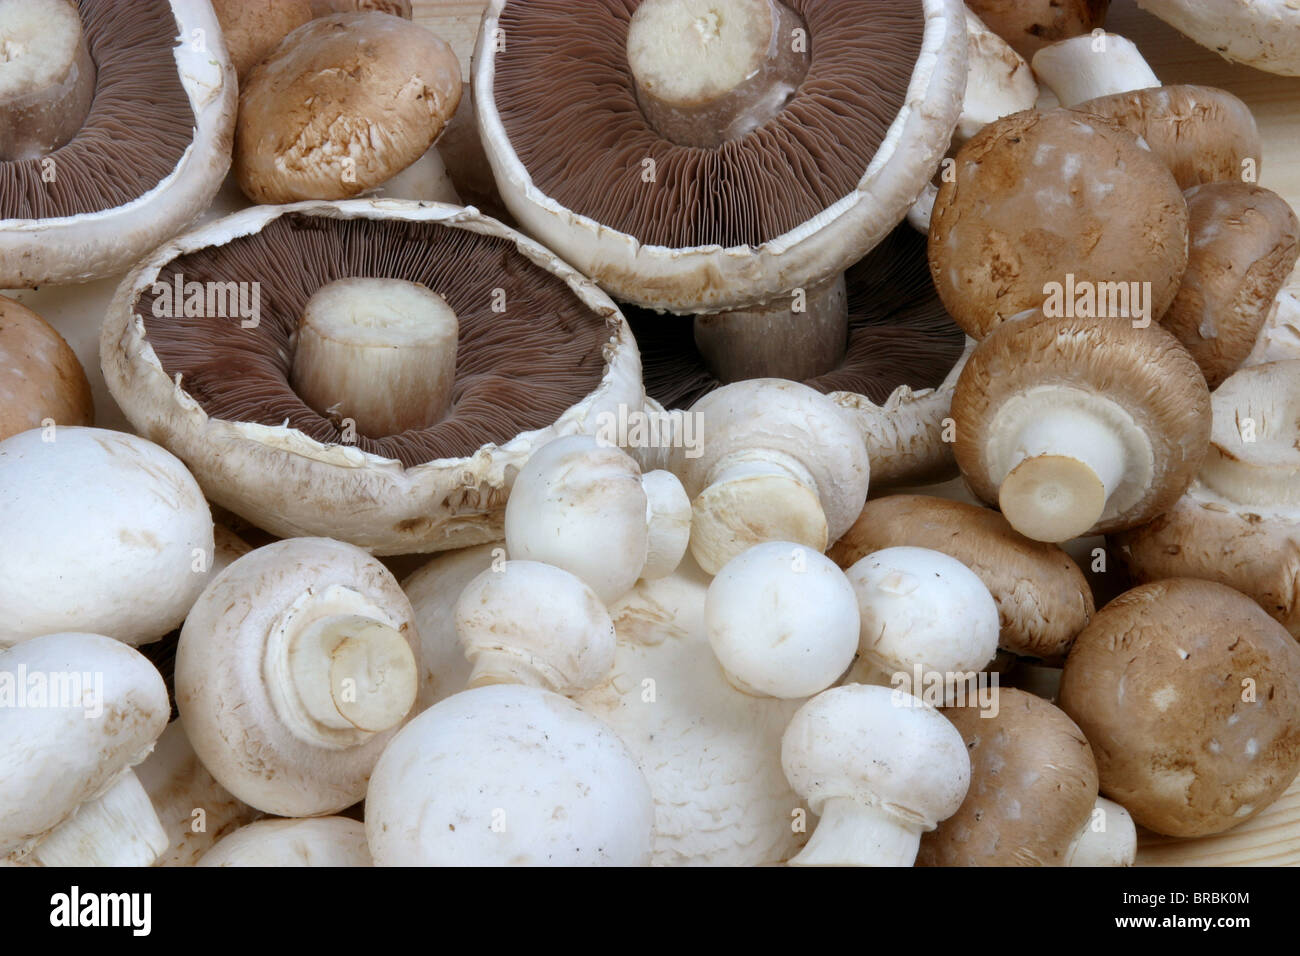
[{"xmin": 988, "ymin": 388, "xmax": 1153, "ymax": 542}]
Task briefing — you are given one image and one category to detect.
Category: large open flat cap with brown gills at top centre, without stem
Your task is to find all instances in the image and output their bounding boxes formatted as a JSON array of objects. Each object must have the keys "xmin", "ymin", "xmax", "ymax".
[{"xmin": 473, "ymin": 0, "xmax": 967, "ymax": 313}]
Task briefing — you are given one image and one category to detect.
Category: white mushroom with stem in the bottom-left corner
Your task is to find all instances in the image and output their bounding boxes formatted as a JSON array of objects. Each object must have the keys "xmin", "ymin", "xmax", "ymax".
[{"xmin": 0, "ymin": 633, "xmax": 168, "ymax": 866}]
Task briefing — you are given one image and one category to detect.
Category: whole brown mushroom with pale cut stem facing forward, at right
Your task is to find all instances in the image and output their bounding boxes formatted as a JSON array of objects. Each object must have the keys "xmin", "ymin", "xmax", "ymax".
[{"xmin": 953, "ymin": 315, "xmax": 1210, "ymax": 541}]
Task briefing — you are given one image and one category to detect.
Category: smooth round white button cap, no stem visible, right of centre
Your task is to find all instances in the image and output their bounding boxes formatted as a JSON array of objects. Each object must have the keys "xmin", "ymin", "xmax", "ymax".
[{"xmin": 705, "ymin": 541, "xmax": 858, "ymax": 697}]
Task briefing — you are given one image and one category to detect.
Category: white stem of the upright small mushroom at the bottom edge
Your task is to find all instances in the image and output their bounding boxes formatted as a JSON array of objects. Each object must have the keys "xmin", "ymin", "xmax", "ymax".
[{"xmin": 790, "ymin": 797, "xmax": 920, "ymax": 866}]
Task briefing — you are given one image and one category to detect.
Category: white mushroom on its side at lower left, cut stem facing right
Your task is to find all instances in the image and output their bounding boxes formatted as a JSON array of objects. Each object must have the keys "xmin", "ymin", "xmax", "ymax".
[{"xmin": 176, "ymin": 538, "xmax": 419, "ymax": 817}]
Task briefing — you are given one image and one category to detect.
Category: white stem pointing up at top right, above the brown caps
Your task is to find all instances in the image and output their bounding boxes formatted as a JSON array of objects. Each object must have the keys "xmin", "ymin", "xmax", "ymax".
[{"xmin": 1034, "ymin": 34, "xmax": 1161, "ymax": 107}]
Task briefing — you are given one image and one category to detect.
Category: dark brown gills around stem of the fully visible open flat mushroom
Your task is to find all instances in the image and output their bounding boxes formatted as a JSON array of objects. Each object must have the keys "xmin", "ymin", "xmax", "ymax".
[{"xmin": 135, "ymin": 213, "xmax": 618, "ymax": 467}]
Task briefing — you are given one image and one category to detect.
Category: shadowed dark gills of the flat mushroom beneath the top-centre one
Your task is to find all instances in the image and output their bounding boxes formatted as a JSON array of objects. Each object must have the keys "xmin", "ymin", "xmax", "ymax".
[{"xmin": 621, "ymin": 224, "xmax": 966, "ymax": 408}]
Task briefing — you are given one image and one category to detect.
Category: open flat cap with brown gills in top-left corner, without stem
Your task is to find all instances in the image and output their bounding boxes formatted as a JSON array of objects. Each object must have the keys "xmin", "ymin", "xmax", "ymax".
[{"xmin": 0, "ymin": 0, "xmax": 237, "ymax": 289}]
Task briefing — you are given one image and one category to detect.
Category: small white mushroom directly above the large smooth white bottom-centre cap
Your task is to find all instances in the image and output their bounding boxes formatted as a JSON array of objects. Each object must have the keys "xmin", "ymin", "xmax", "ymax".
[{"xmin": 455, "ymin": 561, "xmax": 614, "ymax": 696}]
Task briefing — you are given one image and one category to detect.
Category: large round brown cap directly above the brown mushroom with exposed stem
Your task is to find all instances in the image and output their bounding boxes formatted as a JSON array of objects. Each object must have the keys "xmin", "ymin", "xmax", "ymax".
[{"xmin": 930, "ymin": 109, "xmax": 1187, "ymax": 338}]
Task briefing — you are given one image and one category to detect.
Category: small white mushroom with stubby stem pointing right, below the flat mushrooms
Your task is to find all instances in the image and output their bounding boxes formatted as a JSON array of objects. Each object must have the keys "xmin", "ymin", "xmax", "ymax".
[{"xmin": 506, "ymin": 434, "xmax": 690, "ymax": 604}]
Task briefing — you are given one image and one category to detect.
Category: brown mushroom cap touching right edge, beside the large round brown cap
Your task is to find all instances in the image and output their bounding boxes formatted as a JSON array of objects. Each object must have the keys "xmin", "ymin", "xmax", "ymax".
[{"xmin": 1161, "ymin": 182, "xmax": 1300, "ymax": 389}]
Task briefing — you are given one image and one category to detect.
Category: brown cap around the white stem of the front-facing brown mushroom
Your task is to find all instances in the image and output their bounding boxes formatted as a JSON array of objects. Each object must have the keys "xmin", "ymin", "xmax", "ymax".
[{"xmin": 952, "ymin": 313, "xmax": 1212, "ymax": 535}]
